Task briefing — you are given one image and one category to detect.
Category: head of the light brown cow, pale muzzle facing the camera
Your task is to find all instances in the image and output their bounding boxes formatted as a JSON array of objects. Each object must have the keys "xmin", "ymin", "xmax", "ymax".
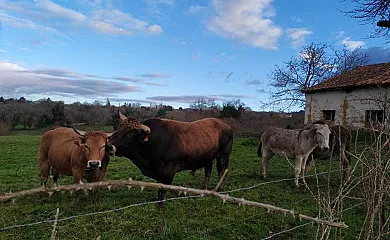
[{"xmin": 73, "ymin": 128, "xmax": 116, "ymax": 169}]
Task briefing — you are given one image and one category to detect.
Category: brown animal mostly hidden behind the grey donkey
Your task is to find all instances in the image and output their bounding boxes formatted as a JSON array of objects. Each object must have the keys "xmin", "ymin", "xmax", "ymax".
[{"xmin": 306, "ymin": 125, "xmax": 352, "ymax": 180}]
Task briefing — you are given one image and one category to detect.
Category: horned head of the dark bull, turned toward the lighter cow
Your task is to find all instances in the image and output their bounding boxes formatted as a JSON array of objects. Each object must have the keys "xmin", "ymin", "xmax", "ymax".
[{"xmin": 111, "ymin": 111, "xmax": 151, "ymax": 155}]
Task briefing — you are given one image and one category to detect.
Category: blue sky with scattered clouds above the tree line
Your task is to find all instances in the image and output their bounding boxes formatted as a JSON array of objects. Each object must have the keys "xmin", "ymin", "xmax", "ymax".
[{"xmin": 0, "ymin": 0, "xmax": 390, "ymax": 111}]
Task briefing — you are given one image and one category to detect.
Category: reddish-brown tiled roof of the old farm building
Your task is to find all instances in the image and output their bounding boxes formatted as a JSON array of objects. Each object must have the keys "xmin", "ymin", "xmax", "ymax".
[{"xmin": 303, "ymin": 62, "xmax": 390, "ymax": 93}]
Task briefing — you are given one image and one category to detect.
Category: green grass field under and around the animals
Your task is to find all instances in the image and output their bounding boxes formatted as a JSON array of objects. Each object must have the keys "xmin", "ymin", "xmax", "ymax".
[{"xmin": 0, "ymin": 132, "xmax": 364, "ymax": 239}]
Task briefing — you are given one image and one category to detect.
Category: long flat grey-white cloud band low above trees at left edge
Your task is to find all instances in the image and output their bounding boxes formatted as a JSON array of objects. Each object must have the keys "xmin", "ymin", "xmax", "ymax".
[{"xmin": 0, "ymin": 61, "xmax": 140, "ymax": 98}]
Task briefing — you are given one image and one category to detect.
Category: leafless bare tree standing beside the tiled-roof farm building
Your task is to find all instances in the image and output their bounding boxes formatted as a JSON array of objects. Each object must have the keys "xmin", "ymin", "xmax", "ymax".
[{"xmin": 263, "ymin": 43, "xmax": 368, "ymax": 110}]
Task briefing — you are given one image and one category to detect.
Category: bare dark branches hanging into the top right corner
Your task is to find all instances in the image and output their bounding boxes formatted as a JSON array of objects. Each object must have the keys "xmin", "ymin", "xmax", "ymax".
[{"xmin": 345, "ymin": 0, "xmax": 390, "ymax": 40}]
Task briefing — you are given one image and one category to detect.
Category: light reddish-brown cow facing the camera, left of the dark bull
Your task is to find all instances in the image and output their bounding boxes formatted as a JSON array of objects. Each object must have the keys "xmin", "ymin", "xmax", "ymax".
[{"xmin": 38, "ymin": 127, "xmax": 116, "ymax": 207}]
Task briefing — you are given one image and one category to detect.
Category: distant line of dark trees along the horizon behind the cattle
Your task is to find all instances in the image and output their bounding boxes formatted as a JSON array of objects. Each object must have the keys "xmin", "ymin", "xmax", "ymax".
[{"xmin": 0, "ymin": 97, "xmax": 253, "ymax": 130}]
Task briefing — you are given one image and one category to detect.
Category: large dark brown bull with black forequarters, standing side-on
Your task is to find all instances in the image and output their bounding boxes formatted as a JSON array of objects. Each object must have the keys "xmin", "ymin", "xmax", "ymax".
[{"xmin": 111, "ymin": 113, "xmax": 233, "ymax": 204}]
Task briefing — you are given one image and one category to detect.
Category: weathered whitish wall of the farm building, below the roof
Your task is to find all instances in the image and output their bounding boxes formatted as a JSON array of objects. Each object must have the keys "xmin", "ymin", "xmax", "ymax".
[{"xmin": 305, "ymin": 88, "xmax": 390, "ymax": 129}]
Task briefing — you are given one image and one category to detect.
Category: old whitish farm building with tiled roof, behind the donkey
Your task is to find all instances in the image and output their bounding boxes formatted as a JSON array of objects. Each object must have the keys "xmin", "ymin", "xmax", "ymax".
[{"xmin": 303, "ymin": 62, "xmax": 390, "ymax": 129}]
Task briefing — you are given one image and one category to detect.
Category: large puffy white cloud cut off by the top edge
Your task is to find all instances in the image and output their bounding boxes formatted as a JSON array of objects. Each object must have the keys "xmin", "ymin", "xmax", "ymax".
[{"xmin": 207, "ymin": 0, "xmax": 282, "ymax": 49}]
